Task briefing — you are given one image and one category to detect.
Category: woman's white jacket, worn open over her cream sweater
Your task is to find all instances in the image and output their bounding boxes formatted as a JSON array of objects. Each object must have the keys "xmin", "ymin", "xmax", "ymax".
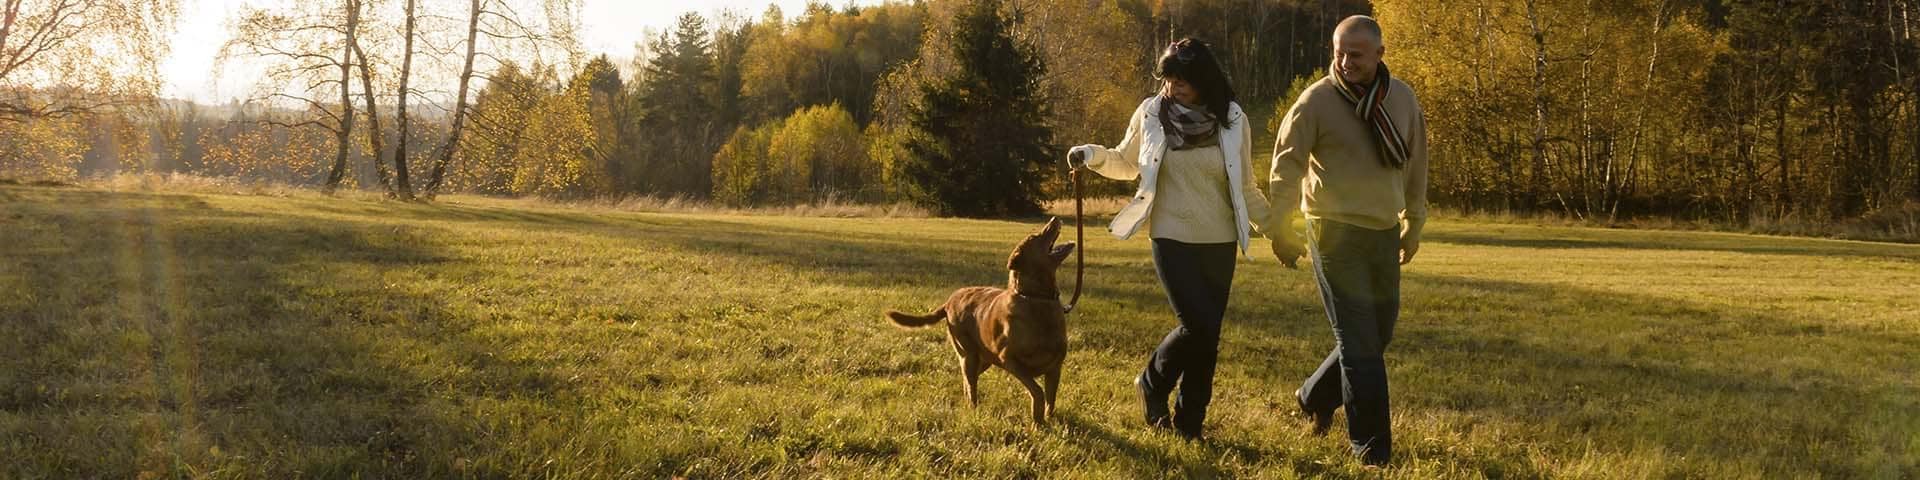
[{"xmin": 1073, "ymin": 96, "xmax": 1267, "ymax": 255}]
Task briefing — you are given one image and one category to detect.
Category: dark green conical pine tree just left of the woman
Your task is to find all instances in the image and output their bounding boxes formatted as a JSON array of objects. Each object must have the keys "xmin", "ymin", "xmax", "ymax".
[{"xmin": 902, "ymin": 0, "xmax": 1058, "ymax": 217}]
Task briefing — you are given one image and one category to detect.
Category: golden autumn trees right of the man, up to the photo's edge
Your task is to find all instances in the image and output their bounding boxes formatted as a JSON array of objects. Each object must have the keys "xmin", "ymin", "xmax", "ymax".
[{"xmin": 1375, "ymin": 0, "xmax": 1920, "ymax": 225}]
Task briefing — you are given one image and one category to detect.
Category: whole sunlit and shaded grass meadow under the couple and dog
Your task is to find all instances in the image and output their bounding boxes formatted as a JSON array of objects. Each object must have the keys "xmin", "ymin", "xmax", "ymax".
[{"xmin": 0, "ymin": 186, "xmax": 1920, "ymax": 478}]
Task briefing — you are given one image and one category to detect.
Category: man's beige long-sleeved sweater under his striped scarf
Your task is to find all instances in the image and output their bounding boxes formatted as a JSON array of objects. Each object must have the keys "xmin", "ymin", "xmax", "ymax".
[{"xmin": 1267, "ymin": 77, "xmax": 1427, "ymax": 238}]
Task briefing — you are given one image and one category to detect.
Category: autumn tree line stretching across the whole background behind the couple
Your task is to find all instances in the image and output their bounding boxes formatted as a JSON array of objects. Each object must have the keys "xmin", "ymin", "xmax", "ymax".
[{"xmin": 0, "ymin": 0, "xmax": 1920, "ymax": 223}]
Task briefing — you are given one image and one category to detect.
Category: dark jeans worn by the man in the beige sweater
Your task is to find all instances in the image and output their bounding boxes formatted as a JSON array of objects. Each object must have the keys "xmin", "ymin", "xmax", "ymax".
[{"xmin": 1300, "ymin": 221, "xmax": 1400, "ymax": 465}]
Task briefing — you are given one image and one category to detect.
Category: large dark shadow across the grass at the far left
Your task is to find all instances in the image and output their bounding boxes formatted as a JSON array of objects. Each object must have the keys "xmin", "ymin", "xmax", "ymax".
[{"xmin": 0, "ymin": 190, "xmax": 568, "ymax": 478}]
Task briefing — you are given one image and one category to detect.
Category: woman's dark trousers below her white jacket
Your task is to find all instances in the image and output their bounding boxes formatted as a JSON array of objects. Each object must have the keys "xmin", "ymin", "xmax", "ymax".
[{"xmin": 1140, "ymin": 238, "xmax": 1236, "ymax": 436}]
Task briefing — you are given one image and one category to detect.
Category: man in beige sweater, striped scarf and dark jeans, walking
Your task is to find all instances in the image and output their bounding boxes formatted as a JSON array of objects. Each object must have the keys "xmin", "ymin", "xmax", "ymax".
[{"xmin": 1267, "ymin": 15, "xmax": 1427, "ymax": 465}]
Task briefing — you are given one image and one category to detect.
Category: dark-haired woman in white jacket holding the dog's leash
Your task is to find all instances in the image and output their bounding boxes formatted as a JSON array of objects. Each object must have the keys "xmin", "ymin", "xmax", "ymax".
[{"xmin": 1068, "ymin": 38, "xmax": 1267, "ymax": 440}]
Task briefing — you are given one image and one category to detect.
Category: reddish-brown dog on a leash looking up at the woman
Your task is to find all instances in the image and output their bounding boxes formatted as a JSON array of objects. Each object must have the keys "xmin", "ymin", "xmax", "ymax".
[{"xmin": 887, "ymin": 219, "xmax": 1073, "ymax": 422}]
